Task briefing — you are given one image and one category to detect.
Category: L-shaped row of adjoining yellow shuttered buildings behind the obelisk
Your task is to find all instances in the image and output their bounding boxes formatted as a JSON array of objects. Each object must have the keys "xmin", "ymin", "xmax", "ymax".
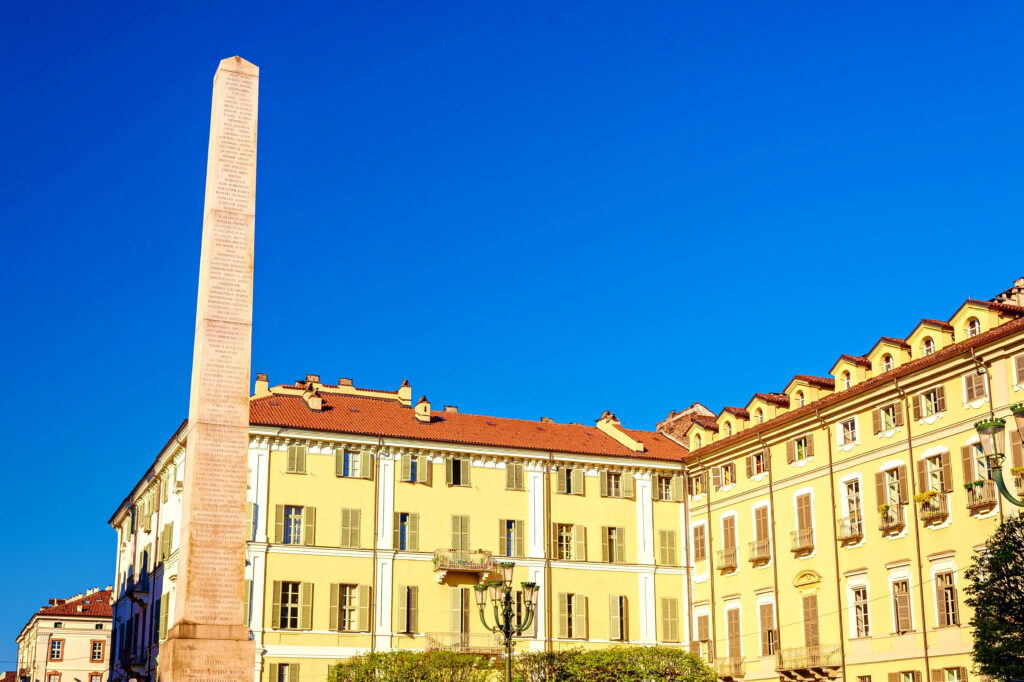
[{"xmin": 111, "ymin": 282, "xmax": 1024, "ymax": 682}]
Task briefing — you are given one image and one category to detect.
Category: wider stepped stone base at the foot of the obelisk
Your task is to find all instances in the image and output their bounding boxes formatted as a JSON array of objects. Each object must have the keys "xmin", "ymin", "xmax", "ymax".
[{"xmin": 159, "ymin": 624, "xmax": 256, "ymax": 682}]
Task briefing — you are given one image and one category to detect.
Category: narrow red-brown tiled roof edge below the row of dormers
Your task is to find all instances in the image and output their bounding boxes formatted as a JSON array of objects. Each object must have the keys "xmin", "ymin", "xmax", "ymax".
[{"xmin": 688, "ymin": 318, "xmax": 1024, "ymax": 457}]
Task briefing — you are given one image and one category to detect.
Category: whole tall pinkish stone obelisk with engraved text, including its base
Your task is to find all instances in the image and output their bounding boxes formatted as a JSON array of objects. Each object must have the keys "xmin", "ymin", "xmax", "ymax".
[{"xmin": 159, "ymin": 56, "xmax": 259, "ymax": 682}]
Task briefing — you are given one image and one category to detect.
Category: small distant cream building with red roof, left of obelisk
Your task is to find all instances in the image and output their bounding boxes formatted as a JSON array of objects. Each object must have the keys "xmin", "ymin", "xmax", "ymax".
[{"xmin": 17, "ymin": 586, "xmax": 113, "ymax": 682}]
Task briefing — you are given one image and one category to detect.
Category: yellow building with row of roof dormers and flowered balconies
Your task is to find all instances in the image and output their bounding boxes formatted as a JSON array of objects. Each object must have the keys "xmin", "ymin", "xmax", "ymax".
[{"xmin": 659, "ymin": 281, "xmax": 1024, "ymax": 682}]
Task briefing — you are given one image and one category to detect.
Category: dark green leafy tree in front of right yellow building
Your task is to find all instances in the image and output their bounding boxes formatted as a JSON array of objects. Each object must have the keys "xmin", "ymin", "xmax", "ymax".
[{"xmin": 965, "ymin": 507, "xmax": 1024, "ymax": 680}]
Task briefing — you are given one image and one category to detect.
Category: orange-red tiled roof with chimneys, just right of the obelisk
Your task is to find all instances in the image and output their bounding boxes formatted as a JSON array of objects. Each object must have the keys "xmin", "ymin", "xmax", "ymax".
[{"xmin": 249, "ymin": 393, "xmax": 686, "ymax": 460}]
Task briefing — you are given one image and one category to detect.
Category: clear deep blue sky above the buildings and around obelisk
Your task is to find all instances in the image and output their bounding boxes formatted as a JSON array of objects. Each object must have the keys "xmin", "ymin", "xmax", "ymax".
[{"xmin": 0, "ymin": 2, "xmax": 1024, "ymax": 669}]
